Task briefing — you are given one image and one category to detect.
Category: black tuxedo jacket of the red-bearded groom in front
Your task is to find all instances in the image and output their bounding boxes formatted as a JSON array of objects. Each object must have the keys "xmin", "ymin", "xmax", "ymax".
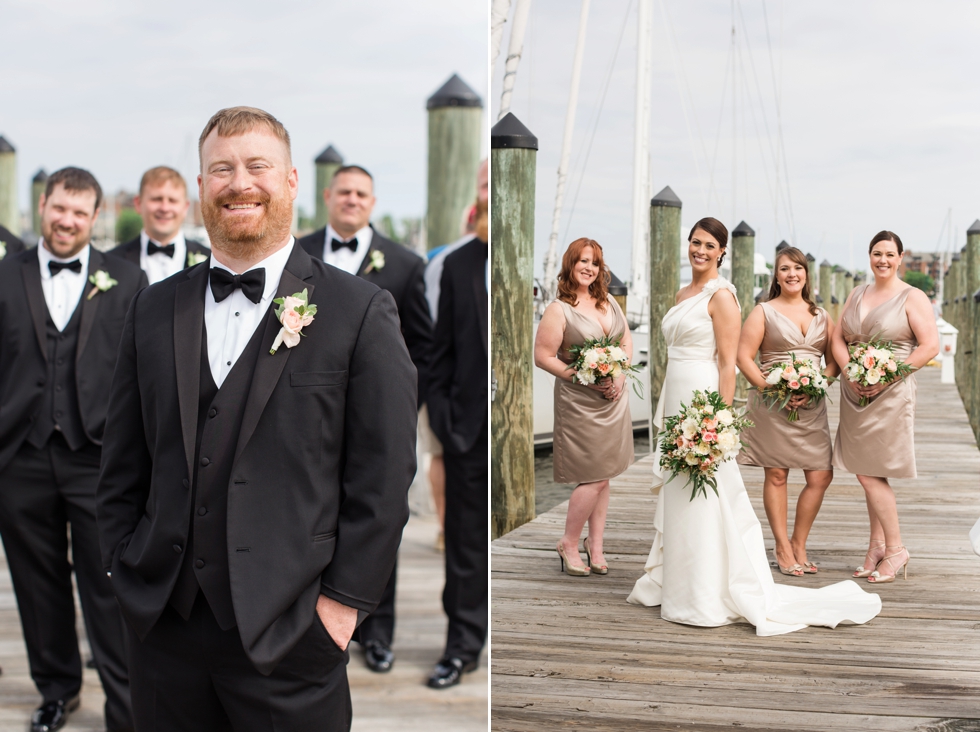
[{"xmin": 96, "ymin": 247, "xmax": 416, "ymax": 674}]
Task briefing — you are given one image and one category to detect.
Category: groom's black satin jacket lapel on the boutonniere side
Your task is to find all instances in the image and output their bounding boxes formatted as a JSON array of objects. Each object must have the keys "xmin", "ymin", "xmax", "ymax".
[{"xmin": 235, "ymin": 244, "xmax": 313, "ymax": 462}]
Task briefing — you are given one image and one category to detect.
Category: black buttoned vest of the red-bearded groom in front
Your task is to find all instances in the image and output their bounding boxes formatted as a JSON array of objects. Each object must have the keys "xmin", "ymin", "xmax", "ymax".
[{"xmin": 170, "ymin": 323, "xmax": 265, "ymax": 630}]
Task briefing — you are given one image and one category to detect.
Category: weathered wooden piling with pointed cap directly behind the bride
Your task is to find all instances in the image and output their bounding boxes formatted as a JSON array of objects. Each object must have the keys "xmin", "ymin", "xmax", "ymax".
[{"xmin": 652, "ymin": 186, "xmax": 683, "ymax": 424}]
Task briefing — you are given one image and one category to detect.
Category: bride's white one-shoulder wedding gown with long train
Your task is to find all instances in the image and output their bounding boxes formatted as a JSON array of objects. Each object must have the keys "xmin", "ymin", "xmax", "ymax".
[{"xmin": 629, "ymin": 278, "xmax": 881, "ymax": 636}]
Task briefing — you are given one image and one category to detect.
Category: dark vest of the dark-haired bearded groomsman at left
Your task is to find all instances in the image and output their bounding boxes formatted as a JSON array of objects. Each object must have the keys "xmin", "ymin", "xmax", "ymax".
[{"xmin": 27, "ymin": 295, "xmax": 88, "ymax": 450}]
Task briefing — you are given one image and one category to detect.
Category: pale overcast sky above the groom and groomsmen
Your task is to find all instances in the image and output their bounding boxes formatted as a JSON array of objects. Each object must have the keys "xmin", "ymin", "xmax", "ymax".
[{"xmin": 0, "ymin": 0, "xmax": 489, "ymax": 226}]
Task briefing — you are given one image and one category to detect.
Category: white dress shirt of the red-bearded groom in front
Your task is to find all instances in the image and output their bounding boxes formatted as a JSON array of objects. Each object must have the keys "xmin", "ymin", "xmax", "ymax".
[{"xmin": 204, "ymin": 237, "xmax": 295, "ymax": 389}]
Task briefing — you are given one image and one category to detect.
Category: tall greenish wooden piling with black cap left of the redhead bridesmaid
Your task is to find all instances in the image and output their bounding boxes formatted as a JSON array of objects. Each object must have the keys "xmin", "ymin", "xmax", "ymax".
[{"xmin": 494, "ymin": 113, "xmax": 550, "ymax": 539}]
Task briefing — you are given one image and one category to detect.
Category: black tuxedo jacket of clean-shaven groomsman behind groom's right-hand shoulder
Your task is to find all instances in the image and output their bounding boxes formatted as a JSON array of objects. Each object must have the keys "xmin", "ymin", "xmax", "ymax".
[{"xmin": 299, "ymin": 227, "xmax": 432, "ymax": 406}]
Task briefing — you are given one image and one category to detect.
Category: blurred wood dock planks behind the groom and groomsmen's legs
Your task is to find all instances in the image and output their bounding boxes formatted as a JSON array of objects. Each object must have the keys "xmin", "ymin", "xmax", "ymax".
[{"xmin": 0, "ymin": 516, "xmax": 487, "ymax": 732}]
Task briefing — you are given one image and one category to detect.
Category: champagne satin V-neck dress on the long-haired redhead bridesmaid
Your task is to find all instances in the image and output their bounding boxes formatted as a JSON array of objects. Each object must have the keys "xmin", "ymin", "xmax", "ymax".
[{"xmin": 553, "ymin": 297, "xmax": 633, "ymax": 483}]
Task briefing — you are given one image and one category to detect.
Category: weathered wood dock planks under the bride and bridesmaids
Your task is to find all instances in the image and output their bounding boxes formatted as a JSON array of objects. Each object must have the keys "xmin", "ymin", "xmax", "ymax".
[{"xmin": 491, "ymin": 369, "xmax": 980, "ymax": 732}]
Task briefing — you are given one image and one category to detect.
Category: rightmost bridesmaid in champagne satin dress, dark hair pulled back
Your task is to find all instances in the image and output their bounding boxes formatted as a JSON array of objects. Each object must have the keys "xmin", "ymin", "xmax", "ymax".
[{"xmin": 833, "ymin": 231, "xmax": 939, "ymax": 583}]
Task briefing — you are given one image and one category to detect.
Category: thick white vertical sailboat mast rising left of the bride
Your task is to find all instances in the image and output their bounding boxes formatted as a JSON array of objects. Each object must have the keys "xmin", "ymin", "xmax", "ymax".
[{"xmin": 629, "ymin": 0, "xmax": 653, "ymax": 320}]
